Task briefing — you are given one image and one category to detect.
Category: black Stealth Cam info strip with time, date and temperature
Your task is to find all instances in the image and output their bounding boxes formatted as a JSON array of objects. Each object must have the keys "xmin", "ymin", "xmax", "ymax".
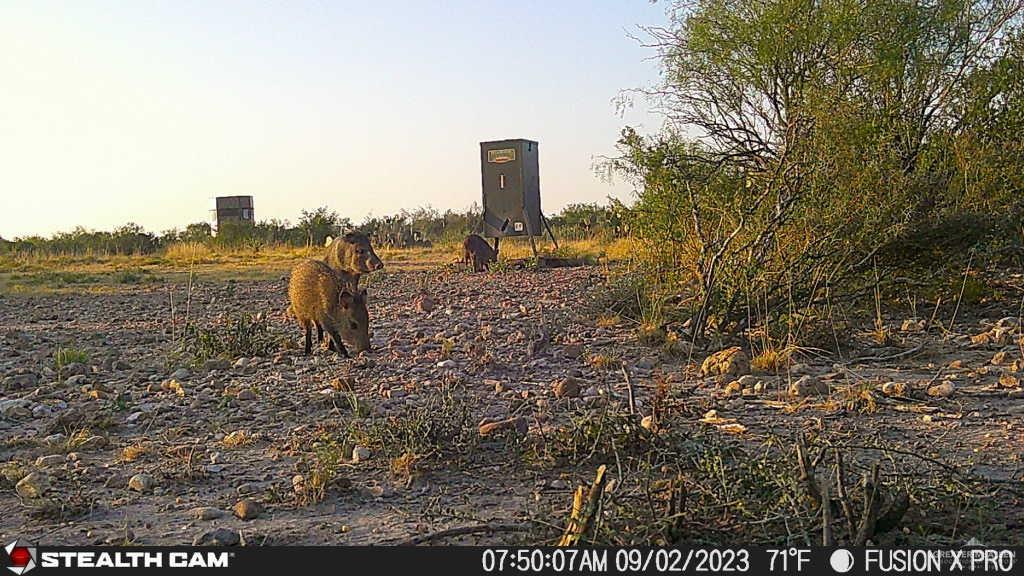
[{"xmin": 0, "ymin": 540, "xmax": 1024, "ymax": 576}]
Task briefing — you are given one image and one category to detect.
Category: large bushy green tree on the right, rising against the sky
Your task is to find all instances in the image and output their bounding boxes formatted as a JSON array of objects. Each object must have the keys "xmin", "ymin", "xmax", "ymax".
[{"xmin": 611, "ymin": 0, "xmax": 1024, "ymax": 336}]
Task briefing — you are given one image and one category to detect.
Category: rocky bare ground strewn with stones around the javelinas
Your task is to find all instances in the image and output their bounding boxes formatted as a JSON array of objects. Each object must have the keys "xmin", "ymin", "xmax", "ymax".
[{"xmin": 0, "ymin": 268, "xmax": 1024, "ymax": 545}]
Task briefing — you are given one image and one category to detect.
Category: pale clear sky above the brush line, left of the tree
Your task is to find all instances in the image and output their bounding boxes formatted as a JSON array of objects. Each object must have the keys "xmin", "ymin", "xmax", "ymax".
[{"xmin": 0, "ymin": 0, "xmax": 666, "ymax": 239}]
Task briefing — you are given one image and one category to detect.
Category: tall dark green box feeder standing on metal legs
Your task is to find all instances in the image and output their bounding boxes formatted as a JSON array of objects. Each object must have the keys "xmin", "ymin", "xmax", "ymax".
[{"xmin": 480, "ymin": 138, "xmax": 557, "ymax": 253}]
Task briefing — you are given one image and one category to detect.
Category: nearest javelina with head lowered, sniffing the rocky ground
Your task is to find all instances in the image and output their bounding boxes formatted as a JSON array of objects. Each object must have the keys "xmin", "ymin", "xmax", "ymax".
[{"xmin": 288, "ymin": 260, "xmax": 370, "ymax": 356}]
